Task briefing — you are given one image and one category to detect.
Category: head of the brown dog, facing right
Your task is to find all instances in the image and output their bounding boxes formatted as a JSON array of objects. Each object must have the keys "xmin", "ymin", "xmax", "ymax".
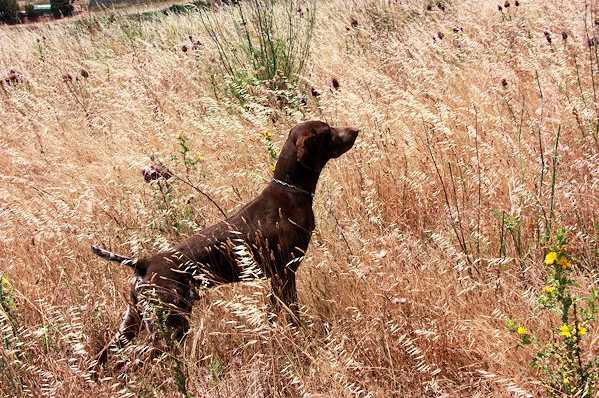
[{"xmin": 290, "ymin": 121, "xmax": 358, "ymax": 170}]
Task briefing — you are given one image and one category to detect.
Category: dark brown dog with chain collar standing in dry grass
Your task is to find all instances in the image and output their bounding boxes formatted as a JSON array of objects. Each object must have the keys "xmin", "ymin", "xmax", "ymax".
[{"xmin": 92, "ymin": 121, "xmax": 358, "ymax": 363}]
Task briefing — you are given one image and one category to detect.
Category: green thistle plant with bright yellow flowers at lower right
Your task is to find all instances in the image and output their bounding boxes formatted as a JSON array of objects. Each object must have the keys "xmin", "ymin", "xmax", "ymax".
[{"xmin": 506, "ymin": 228, "xmax": 599, "ymax": 397}]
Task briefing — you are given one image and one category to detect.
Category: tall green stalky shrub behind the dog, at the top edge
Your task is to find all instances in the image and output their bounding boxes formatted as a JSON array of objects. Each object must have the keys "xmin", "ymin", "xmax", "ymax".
[{"xmin": 201, "ymin": 0, "xmax": 315, "ymax": 96}]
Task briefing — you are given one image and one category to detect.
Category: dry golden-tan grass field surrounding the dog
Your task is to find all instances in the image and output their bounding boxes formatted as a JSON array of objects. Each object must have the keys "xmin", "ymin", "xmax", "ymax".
[{"xmin": 0, "ymin": 0, "xmax": 599, "ymax": 397}]
